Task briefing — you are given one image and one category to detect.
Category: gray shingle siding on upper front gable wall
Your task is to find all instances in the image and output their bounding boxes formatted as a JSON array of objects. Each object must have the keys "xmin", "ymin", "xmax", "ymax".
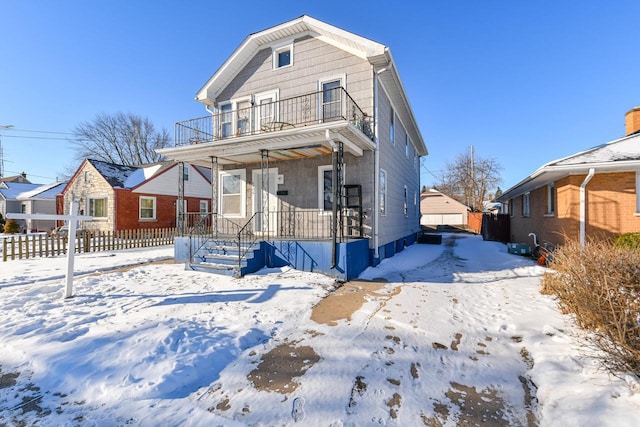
[{"xmin": 216, "ymin": 37, "xmax": 373, "ymax": 115}]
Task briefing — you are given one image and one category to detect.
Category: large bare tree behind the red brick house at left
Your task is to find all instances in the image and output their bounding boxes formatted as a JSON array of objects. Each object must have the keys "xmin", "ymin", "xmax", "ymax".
[{"xmin": 72, "ymin": 113, "xmax": 171, "ymax": 166}]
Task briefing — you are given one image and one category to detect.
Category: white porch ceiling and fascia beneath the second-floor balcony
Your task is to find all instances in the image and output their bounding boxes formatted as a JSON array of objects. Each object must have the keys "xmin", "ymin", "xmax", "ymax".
[{"xmin": 157, "ymin": 122, "xmax": 375, "ymax": 167}]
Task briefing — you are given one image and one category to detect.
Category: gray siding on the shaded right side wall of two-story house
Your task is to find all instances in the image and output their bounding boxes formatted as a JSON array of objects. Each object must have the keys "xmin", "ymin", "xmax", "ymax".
[{"xmin": 378, "ymin": 85, "xmax": 420, "ymax": 245}]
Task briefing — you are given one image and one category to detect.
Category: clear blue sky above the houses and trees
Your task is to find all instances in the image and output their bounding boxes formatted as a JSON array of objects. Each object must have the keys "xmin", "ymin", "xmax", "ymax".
[{"xmin": 0, "ymin": 0, "xmax": 640, "ymax": 190}]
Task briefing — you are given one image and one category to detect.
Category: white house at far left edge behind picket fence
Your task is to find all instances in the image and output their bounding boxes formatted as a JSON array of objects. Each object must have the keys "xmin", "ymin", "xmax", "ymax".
[{"xmin": 0, "ymin": 182, "xmax": 67, "ymax": 232}]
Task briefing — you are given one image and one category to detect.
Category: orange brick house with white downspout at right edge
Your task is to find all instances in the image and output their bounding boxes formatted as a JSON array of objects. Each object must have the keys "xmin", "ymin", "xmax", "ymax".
[{"xmin": 497, "ymin": 107, "xmax": 640, "ymax": 245}]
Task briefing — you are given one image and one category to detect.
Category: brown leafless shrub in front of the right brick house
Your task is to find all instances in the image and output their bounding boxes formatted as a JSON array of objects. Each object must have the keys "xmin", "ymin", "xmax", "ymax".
[{"xmin": 542, "ymin": 241, "xmax": 640, "ymax": 377}]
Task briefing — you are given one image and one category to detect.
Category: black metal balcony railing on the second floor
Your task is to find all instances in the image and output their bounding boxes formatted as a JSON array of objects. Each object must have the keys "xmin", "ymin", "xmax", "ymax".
[{"xmin": 174, "ymin": 87, "xmax": 373, "ymax": 146}]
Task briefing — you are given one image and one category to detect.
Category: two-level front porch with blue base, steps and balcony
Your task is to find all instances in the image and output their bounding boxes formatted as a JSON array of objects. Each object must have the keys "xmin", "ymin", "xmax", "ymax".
[{"xmin": 159, "ymin": 88, "xmax": 375, "ymax": 279}]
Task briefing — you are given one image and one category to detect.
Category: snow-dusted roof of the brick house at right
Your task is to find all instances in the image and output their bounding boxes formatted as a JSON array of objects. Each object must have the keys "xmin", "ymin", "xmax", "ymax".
[{"xmin": 496, "ymin": 133, "xmax": 640, "ymax": 202}]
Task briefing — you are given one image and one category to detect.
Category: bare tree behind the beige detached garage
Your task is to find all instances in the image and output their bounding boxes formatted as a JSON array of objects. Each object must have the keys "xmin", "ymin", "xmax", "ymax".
[{"xmin": 436, "ymin": 147, "xmax": 502, "ymax": 212}]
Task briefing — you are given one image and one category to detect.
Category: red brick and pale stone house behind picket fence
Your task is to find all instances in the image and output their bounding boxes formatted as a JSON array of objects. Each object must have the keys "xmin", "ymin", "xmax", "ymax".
[{"xmin": 57, "ymin": 159, "xmax": 211, "ymax": 231}]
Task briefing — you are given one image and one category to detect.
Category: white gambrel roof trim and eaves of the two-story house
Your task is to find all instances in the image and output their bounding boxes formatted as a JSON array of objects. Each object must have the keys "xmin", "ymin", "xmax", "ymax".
[{"xmin": 195, "ymin": 15, "xmax": 428, "ymax": 156}]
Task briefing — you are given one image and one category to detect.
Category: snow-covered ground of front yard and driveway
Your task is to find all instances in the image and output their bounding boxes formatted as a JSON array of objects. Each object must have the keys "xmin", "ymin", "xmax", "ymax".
[{"xmin": 0, "ymin": 234, "xmax": 640, "ymax": 427}]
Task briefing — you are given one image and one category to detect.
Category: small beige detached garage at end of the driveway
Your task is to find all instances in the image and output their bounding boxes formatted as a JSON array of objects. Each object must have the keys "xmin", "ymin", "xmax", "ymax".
[{"xmin": 420, "ymin": 189, "xmax": 469, "ymax": 226}]
